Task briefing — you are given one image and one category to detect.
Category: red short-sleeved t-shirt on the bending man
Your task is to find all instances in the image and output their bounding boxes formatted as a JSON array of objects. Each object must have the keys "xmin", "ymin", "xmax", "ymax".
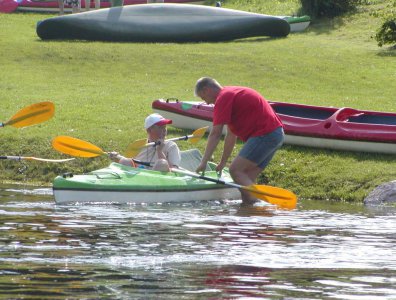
[{"xmin": 213, "ymin": 86, "xmax": 283, "ymax": 141}]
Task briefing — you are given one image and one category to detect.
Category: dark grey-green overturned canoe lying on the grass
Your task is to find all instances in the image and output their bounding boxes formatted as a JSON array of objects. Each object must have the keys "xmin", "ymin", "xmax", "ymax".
[{"xmin": 36, "ymin": 4, "xmax": 290, "ymax": 42}]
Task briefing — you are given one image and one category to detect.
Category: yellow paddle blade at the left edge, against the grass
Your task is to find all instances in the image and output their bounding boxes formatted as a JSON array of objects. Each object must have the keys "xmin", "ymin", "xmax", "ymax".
[{"xmin": 0, "ymin": 101, "xmax": 55, "ymax": 128}]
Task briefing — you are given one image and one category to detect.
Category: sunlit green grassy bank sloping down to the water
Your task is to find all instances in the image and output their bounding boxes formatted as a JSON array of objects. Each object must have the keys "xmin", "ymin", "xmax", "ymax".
[{"xmin": 0, "ymin": 0, "xmax": 396, "ymax": 201}]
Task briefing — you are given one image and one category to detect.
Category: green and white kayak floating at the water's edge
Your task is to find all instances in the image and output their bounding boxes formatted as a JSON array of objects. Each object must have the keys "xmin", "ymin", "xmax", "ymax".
[{"xmin": 53, "ymin": 150, "xmax": 240, "ymax": 204}]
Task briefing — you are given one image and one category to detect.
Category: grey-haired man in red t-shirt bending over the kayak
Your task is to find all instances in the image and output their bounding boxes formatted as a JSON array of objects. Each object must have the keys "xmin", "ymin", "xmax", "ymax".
[{"xmin": 195, "ymin": 77, "xmax": 284, "ymax": 204}]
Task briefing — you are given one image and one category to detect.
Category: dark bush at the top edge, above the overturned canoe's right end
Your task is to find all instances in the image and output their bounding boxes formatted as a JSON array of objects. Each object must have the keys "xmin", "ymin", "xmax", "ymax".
[{"xmin": 300, "ymin": 0, "xmax": 362, "ymax": 18}]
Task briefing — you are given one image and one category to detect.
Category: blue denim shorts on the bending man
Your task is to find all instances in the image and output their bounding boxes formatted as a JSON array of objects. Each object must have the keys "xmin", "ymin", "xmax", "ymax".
[{"xmin": 239, "ymin": 127, "xmax": 284, "ymax": 169}]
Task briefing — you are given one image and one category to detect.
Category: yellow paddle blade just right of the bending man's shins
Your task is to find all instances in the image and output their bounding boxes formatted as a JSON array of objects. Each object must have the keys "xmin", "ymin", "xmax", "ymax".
[{"xmin": 242, "ymin": 184, "xmax": 297, "ymax": 209}]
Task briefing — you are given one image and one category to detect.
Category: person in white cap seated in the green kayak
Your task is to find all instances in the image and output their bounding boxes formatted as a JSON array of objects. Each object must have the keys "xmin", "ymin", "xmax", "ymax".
[{"xmin": 109, "ymin": 114, "xmax": 181, "ymax": 172}]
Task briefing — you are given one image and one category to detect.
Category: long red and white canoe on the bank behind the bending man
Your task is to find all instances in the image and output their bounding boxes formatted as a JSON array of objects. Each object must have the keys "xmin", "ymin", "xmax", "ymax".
[{"xmin": 152, "ymin": 99, "xmax": 396, "ymax": 154}]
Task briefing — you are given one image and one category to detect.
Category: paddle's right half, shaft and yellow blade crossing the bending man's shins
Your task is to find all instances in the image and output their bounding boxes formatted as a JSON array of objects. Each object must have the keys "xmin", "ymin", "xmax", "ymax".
[{"xmin": 171, "ymin": 168, "xmax": 297, "ymax": 209}]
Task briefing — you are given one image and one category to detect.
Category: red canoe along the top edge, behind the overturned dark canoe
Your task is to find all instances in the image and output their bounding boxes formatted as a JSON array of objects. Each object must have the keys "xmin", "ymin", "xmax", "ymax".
[{"xmin": 0, "ymin": 0, "xmax": 204, "ymax": 13}]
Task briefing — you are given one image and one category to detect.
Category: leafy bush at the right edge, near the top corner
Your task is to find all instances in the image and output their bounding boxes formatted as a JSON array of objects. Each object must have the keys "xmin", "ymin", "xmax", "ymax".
[{"xmin": 374, "ymin": 0, "xmax": 396, "ymax": 47}]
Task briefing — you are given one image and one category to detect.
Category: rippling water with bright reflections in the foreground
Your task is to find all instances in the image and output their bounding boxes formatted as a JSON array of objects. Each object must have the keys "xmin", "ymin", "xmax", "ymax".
[{"xmin": 0, "ymin": 186, "xmax": 396, "ymax": 300}]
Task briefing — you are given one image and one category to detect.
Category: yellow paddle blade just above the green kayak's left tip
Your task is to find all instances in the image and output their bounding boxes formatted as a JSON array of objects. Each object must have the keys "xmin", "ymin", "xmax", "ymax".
[{"xmin": 52, "ymin": 136, "xmax": 106, "ymax": 157}]
